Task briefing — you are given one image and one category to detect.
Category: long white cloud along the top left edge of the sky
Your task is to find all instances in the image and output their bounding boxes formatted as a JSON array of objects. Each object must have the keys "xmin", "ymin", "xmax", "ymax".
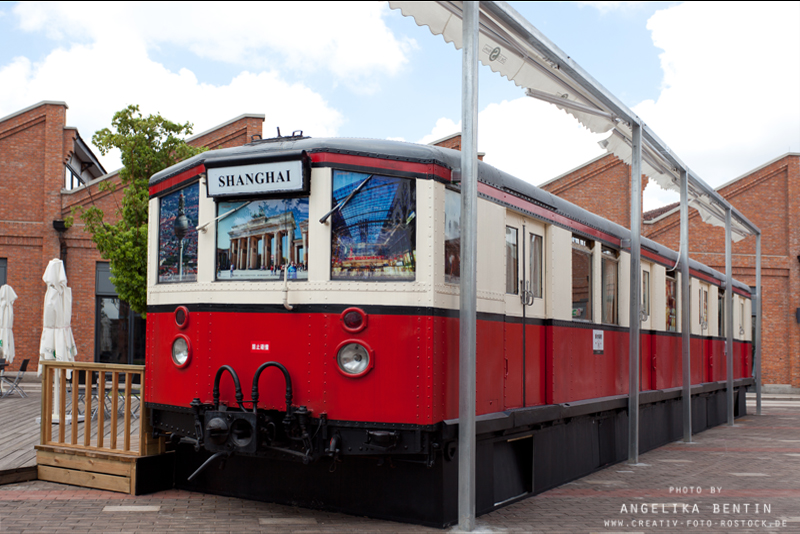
[{"xmin": 15, "ymin": 2, "xmax": 416, "ymax": 93}]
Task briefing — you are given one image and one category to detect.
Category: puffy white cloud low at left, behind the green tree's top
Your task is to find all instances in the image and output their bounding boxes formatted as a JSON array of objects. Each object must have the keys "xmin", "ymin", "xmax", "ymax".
[{"xmin": 0, "ymin": 36, "xmax": 343, "ymax": 170}]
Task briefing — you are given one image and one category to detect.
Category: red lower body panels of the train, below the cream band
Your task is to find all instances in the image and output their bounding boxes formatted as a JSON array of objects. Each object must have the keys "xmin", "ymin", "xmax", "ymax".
[{"xmin": 145, "ymin": 311, "xmax": 752, "ymax": 425}]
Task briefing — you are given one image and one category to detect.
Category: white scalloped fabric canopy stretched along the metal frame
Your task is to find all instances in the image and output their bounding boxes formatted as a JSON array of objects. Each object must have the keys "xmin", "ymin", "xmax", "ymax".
[{"xmin": 389, "ymin": 1, "xmax": 752, "ymax": 241}]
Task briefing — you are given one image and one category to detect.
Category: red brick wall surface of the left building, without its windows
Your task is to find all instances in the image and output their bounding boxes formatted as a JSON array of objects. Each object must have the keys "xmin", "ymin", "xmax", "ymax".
[{"xmin": 0, "ymin": 102, "xmax": 264, "ymax": 371}]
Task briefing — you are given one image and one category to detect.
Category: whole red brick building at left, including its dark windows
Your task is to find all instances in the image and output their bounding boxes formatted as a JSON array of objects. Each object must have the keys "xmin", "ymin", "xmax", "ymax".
[{"xmin": 0, "ymin": 101, "xmax": 264, "ymax": 370}]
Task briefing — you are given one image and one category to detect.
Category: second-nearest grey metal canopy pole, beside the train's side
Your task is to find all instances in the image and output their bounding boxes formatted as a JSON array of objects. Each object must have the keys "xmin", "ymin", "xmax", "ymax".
[{"xmin": 628, "ymin": 124, "xmax": 642, "ymax": 464}]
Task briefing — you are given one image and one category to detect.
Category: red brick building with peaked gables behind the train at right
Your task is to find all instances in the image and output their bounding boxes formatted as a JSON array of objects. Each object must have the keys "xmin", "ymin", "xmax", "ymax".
[{"xmin": 540, "ymin": 154, "xmax": 800, "ymax": 391}]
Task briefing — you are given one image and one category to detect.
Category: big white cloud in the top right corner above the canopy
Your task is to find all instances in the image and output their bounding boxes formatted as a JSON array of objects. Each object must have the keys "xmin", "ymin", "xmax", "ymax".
[{"xmin": 634, "ymin": 2, "xmax": 800, "ymax": 187}]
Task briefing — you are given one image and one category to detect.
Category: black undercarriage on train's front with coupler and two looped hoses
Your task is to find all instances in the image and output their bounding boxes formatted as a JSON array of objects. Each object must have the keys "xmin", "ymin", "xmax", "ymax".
[{"xmin": 147, "ymin": 362, "xmax": 446, "ymax": 480}]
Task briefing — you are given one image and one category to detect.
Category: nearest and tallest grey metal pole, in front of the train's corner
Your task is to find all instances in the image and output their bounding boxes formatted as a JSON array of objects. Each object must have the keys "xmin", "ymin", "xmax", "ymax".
[{"xmin": 458, "ymin": 2, "xmax": 479, "ymax": 532}]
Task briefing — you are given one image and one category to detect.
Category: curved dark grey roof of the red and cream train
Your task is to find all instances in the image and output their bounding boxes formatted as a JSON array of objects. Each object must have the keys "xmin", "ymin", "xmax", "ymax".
[{"xmin": 150, "ymin": 137, "xmax": 751, "ymax": 293}]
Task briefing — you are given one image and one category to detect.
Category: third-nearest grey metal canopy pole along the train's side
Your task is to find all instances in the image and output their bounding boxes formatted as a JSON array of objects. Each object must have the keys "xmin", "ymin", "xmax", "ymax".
[{"xmin": 679, "ymin": 170, "xmax": 692, "ymax": 443}]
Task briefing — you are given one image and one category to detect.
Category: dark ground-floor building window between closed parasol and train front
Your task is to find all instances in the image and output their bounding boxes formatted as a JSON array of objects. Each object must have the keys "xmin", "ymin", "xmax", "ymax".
[{"xmin": 94, "ymin": 262, "xmax": 146, "ymax": 365}]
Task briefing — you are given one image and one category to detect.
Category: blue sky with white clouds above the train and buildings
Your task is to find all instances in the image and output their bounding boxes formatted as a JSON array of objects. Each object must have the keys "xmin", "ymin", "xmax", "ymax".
[{"xmin": 0, "ymin": 2, "xmax": 800, "ymax": 209}]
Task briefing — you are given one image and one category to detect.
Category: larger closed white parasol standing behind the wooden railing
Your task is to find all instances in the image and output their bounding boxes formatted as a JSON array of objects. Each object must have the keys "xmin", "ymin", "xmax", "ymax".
[{"xmin": 39, "ymin": 259, "xmax": 78, "ymax": 375}]
